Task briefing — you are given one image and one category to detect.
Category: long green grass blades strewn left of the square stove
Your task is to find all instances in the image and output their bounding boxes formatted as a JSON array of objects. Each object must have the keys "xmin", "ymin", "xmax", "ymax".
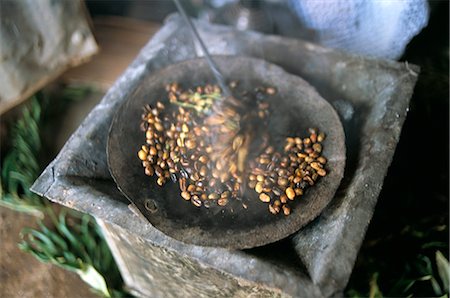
[{"xmin": 0, "ymin": 88, "xmax": 130, "ymax": 297}]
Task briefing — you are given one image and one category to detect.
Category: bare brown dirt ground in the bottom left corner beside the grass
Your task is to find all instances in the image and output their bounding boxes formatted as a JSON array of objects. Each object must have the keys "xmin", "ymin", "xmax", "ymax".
[{"xmin": 0, "ymin": 207, "xmax": 97, "ymax": 298}]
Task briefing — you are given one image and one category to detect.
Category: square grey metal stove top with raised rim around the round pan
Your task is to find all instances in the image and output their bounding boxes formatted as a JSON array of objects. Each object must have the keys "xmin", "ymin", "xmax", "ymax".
[{"xmin": 32, "ymin": 15, "xmax": 418, "ymax": 297}]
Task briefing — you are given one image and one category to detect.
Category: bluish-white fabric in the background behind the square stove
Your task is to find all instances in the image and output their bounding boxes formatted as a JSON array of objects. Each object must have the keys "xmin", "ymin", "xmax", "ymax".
[{"xmin": 289, "ymin": 0, "xmax": 429, "ymax": 59}]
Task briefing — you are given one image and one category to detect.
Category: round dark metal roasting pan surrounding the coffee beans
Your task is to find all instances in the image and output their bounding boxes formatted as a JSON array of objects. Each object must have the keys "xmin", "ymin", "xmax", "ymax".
[{"xmin": 107, "ymin": 56, "xmax": 345, "ymax": 249}]
